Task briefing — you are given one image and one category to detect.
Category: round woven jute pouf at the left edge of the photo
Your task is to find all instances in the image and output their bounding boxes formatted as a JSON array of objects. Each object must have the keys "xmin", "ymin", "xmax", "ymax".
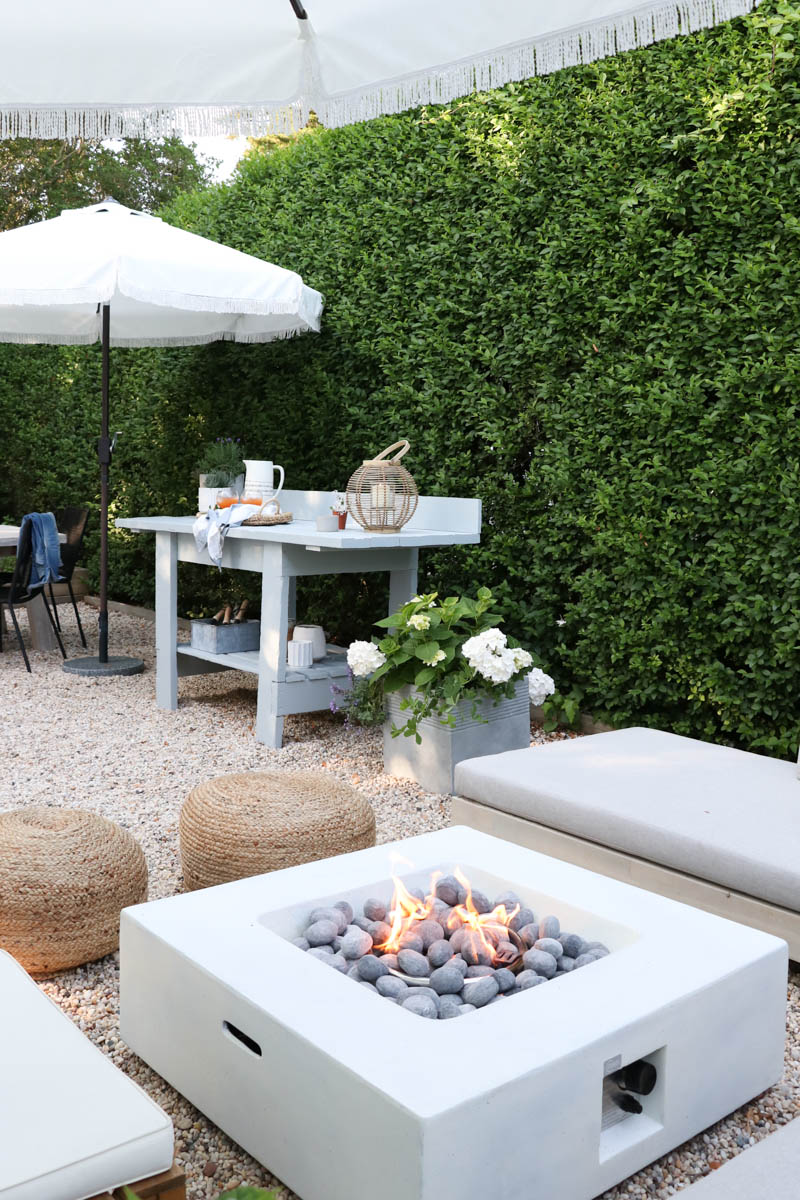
[{"xmin": 0, "ymin": 808, "xmax": 148, "ymax": 974}]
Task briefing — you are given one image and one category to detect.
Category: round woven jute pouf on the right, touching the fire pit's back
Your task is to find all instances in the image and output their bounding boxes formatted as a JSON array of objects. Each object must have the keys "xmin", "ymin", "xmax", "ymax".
[{"xmin": 180, "ymin": 770, "xmax": 375, "ymax": 892}]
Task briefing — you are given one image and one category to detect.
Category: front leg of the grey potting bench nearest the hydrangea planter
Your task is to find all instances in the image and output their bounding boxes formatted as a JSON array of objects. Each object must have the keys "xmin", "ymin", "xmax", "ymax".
[{"xmin": 255, "ymin": 545, "xmax": 291, "ymax": 750}]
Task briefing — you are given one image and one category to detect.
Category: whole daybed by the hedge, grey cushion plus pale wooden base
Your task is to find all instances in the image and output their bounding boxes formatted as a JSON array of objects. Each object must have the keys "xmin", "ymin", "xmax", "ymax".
[{"xmin": 451, "ymin": 728, "xmax": 800, "ymax": 960}]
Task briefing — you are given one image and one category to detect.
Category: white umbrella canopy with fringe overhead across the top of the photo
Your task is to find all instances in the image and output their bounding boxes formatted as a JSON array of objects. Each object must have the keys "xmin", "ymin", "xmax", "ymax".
[{"xmin": 0, "ymin": 0, "xmax": 758, "ymax": 138}]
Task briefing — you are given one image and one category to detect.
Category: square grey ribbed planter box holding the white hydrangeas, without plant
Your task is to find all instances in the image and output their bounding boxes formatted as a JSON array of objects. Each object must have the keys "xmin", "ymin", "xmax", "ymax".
[{"xmin": 384, "ymin": 676, "xmax": 530, "ymax": 793}]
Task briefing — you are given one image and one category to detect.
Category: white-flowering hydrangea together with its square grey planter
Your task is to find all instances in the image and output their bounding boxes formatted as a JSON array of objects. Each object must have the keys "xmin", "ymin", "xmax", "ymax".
[{"xmin": 348, "ymin": 588, "xmax": 554, "ymax": 792}]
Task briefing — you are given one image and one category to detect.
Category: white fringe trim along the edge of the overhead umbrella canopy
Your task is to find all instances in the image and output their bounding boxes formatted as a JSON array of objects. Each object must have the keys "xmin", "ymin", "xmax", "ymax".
[{"xmin": 0, "ymin": 0, "xmax": 760, "ymax": 139}]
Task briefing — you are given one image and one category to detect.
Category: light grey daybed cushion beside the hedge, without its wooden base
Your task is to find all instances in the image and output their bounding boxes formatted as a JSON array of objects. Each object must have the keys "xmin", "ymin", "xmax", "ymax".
[{"xmin": 456, "ymin": 728, "xmax": 800, "ymax": 912}]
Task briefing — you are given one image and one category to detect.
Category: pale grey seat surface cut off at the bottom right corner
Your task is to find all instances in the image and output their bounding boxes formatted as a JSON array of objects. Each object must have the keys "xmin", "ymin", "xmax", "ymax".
[{"xmin": 680, "ymin": 1121, "xmax": 800, "ymax": 1200}]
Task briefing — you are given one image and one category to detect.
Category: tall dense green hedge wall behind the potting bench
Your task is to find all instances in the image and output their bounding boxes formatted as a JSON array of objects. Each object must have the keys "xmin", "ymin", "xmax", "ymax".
[{"xmin": 0, "ymin": 0, "xmax": 800, "ymax": 756}]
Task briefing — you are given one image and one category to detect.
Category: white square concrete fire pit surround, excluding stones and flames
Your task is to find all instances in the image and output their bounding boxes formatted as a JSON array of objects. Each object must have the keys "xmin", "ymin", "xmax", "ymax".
[{"xmin": 120, "ymin": 828, "xmax": 787, "ymax": 1200}]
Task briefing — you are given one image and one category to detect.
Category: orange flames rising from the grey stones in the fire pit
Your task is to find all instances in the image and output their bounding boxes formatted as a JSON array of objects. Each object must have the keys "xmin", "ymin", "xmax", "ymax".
[{"xmin": 375, "ymin": 868, "xmax": 519, "ymax": 965}]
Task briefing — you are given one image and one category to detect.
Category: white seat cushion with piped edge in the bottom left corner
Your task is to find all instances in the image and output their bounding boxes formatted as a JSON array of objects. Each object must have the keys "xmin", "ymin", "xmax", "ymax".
[{"xmin": 0, "ymin": 950, "xmax": 173, "ymax": 1200}]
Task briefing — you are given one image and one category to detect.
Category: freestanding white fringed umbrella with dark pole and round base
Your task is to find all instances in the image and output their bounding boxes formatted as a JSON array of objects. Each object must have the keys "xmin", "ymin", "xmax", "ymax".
[{"xmin": 0, "ymin": 200, "xmax": 323, "ymax": 674}]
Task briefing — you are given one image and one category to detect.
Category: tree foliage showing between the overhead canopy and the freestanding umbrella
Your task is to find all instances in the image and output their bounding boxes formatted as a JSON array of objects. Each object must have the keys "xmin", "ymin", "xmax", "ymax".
[{"xmin": 0, "ymin": 138, "xmax": 210, "ymax": 229}]
